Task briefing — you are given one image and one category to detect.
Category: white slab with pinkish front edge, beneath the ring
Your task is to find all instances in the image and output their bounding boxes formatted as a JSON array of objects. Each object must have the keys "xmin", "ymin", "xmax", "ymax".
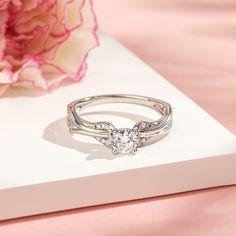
[{"xmin": 0, "ymin": 32, "xmax": 236, "ymax": 220}]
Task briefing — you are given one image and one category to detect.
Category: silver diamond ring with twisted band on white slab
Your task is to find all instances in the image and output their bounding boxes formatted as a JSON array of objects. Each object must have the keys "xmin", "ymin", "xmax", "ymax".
[{"xmin": 67, "ymin": 94, "xmax": 172, "ymax": 154}]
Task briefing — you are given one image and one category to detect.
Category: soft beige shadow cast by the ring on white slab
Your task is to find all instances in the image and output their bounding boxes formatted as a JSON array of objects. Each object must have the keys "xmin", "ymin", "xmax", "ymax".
[{"xmin": 42, "ymin": 111, "xmax": 157, "ymax": 160}]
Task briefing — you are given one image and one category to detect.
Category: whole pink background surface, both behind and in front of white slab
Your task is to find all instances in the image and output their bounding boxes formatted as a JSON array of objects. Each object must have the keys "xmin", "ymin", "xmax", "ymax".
[{"xmin": 0, "ymin": 0, "xmax": 236, "ymax": 236}]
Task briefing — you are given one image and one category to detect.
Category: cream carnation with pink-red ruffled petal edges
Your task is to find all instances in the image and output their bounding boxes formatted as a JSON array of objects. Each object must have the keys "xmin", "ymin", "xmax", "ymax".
[{"xmin": 0, "ymin": 0, "xmax": 98, "ymax": 95}]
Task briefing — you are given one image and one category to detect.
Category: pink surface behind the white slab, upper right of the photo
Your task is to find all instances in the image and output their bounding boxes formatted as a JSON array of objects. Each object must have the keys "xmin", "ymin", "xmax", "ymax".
[{"xmin": 96, "ymin": 0, "xmax": 236, "ymax": 133}]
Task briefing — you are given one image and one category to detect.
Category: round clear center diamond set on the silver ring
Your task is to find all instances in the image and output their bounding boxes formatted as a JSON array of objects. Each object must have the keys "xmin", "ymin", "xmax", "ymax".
[{"xmin": 111, "ymin": 128, "xmax": 140, "ymax": 153}]
